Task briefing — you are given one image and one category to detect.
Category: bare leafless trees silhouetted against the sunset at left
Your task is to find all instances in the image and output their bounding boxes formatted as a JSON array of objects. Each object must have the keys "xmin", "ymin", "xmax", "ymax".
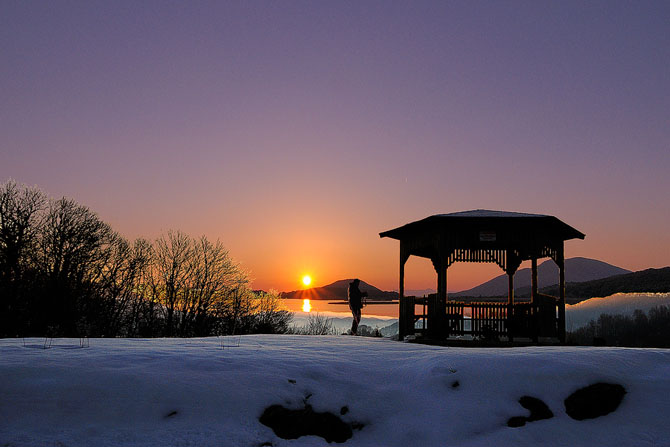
[{"xmin": 0, "ymin": 180, "xmax": 291, "ymax": 337}]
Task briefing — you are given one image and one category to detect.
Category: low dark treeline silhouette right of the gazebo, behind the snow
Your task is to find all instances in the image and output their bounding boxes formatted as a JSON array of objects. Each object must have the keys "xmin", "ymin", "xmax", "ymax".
[{"xmin": 567, "ymin": 306, "xmax": 670, "ymax": 348}]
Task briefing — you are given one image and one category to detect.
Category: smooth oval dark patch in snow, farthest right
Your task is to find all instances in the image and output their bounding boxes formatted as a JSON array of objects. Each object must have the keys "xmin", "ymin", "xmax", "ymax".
[{"xmin": 564, "ymin": 382, "xmax": 626, "ymax": 421}]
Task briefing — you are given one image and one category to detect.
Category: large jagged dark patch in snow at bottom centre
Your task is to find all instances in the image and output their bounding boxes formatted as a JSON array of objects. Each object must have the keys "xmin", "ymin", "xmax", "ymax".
[{"xmin": 259, "ymin": 405, "xmax": 362, "ymax": 443}]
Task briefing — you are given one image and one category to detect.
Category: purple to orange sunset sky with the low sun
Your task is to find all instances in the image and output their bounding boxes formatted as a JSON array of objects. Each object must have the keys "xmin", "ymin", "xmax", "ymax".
[{"xmin": 0, "ymin": 0, "xmax": 670, "ymax": 291}]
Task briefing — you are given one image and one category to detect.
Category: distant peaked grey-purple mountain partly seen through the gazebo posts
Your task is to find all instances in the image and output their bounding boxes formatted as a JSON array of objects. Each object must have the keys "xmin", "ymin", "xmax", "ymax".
[{"xmin": 449, "ymin": 258, "xmax": 631, "ymax": 298}]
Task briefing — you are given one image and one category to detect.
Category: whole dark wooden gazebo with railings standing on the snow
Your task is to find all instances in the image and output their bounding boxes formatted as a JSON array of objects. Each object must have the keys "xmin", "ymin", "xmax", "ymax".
[{"xmin": 379, "ymin": 210, "xmax": 584, "ymax": 342}]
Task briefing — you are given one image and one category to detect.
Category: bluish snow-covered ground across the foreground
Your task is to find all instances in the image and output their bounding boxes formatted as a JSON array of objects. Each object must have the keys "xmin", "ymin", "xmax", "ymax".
[{"xmin": 0, "ymin": 335, "xmax": 670, "ymax": 447}]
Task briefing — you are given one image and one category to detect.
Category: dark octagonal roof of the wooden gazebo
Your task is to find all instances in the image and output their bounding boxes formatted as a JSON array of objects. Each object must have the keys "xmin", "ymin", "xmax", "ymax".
[{"xmin": 379, "ymin": 210, "xmax": 584, "ymax": 259}]
